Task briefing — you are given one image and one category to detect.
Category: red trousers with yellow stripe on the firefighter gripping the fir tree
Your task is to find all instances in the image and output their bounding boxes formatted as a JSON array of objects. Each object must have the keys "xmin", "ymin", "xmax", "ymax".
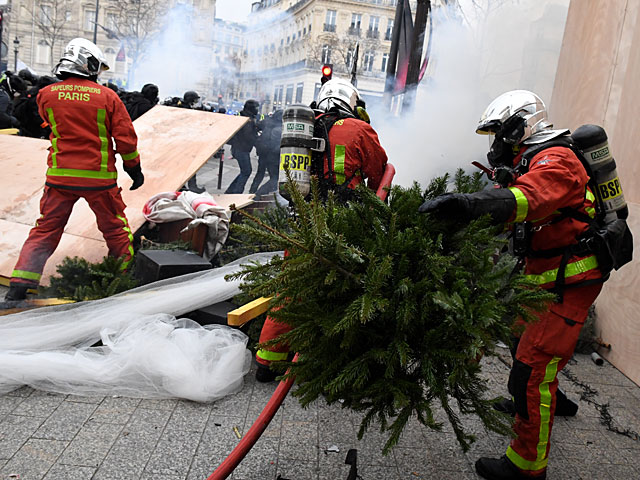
[{"xmin": 507, "ymin": 284, "xmax": 602, "ymax": 475}]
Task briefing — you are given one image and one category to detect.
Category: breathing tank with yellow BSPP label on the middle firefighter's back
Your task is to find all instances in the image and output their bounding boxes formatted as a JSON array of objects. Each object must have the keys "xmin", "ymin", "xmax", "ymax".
[{"xmin": 278, "ymin": 105, "xmax": 325, "ymax": 200}]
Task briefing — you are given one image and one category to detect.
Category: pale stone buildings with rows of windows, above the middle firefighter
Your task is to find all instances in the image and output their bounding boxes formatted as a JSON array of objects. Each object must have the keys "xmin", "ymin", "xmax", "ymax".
[{"xmin": 239, "ymin": 0, "xmax": 415, "ymax": 112}]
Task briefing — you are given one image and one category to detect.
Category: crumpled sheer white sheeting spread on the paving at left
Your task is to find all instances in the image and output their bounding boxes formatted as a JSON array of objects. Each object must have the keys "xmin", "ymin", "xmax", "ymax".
[{"xmin": 0, "ymin": 252, "xmax": 281, "ymax": 402}]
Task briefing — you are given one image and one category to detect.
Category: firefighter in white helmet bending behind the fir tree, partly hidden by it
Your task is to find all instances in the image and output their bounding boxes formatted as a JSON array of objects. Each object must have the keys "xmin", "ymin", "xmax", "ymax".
[{"xmin": 256, "ymin": 79, "xmax": 387, "ymax": 382}]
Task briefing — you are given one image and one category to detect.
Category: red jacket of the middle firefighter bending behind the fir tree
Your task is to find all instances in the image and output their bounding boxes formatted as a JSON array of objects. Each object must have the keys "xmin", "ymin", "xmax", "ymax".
[{"xmin": 324, "ymin": 118, "xmax": 387, "ymax": 191}]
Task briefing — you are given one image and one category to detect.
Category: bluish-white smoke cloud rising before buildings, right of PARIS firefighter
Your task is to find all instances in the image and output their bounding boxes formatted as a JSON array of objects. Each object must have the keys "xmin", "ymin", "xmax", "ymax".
[{"xmin": 129, "ymin": 3, "xmax": 213, "ymax": 100}]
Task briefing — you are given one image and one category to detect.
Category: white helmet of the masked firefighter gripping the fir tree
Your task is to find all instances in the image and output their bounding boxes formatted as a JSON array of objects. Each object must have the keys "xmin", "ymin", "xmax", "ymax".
[{"xmin": 476, "ymin": 90, "xmax": 553, "ymax": 145}]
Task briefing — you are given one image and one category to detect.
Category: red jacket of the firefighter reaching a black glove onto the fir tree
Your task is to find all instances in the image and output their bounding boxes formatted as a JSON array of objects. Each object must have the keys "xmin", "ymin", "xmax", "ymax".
[{"xmin": 509, "ymin": 147, "xmax": 601, "ymax": 315}]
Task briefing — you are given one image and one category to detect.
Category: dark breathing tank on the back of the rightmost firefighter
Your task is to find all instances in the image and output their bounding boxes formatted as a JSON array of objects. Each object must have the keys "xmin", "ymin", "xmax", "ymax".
[{"xmin": 571, "ymin": 125, "xmax": 629, "ymax": 219}]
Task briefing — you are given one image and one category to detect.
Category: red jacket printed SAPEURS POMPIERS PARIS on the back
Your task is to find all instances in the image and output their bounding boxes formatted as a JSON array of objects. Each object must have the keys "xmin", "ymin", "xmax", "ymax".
[{"xmin": 37, "ymin": 77, "xmax": 140, "ymax": 190}]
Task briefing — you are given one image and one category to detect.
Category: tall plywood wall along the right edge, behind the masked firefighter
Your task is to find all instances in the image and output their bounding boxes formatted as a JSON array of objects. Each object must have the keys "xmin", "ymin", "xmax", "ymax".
[{"xmin": 549, "ymin": 0, "xmax": 640, "ymax": 385}]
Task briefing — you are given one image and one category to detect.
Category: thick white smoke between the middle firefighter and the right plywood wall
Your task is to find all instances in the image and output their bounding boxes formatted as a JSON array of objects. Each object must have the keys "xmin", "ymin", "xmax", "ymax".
[{"xmin": 372, "ymin": 0, "xmax": 569, "ymax": 188}]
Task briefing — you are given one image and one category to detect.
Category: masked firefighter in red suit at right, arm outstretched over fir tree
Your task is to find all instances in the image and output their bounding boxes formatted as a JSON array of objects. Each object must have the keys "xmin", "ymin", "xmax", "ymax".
[{"xmin": 420, "ymin": 90, "xmax": 602, "ymax": 480}]
